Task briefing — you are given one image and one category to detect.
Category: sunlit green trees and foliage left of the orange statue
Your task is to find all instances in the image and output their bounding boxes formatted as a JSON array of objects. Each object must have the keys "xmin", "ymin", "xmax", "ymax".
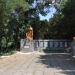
[{"xmin": 0, "ymin": 0, "xmax": 29, "ymax": 51}]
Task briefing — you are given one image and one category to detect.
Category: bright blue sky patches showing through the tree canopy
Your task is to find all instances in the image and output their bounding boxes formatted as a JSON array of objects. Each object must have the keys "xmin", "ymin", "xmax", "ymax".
[{"xmin": 32, "ymin": 0, "xmax": 56, "ymax": 21}]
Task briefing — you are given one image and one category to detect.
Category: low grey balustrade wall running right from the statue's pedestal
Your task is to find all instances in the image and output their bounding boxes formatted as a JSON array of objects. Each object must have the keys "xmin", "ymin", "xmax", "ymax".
[{"xmin": 34, "ymin": 40, "xmax": 71, "ymax": 49}]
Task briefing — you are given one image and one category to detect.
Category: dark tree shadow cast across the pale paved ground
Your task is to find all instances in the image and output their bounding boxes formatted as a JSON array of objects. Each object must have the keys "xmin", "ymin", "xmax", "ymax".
[{"xmin": 37, "ymin": 54, "xmax": 75, "ymax": 75}]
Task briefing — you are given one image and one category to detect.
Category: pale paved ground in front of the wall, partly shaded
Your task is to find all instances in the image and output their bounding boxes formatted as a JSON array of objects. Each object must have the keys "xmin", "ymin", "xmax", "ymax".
[{"xmin": 0, "ymin": 53, "xmax": 75, "ymax": 75}]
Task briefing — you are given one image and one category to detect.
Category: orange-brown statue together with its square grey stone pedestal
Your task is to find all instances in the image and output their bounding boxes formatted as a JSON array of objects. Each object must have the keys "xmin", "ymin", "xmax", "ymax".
[{"xmin": 21, "ymin": 26, "xmax": 34, "ymax": 52}]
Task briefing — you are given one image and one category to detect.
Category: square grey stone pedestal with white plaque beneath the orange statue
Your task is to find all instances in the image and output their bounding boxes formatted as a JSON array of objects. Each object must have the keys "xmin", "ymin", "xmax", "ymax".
[{"xmin": 21, "ymin": 40, "xmax": 34, "ymax": 53}]
